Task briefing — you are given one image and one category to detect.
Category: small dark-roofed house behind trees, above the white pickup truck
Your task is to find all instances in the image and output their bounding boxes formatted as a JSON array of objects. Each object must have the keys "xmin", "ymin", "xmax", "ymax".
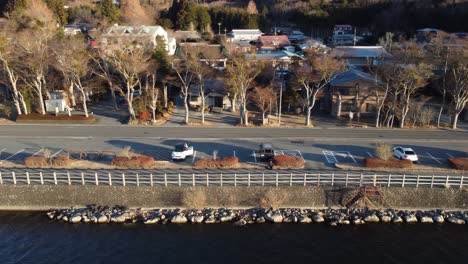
[{"xmin": 190, "ymin": 79, "xmax": 231, "ymax": 109}]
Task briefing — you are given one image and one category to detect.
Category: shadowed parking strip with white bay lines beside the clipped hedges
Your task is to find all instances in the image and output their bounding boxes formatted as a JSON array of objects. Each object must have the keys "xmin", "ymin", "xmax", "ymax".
[{"xmin": 0, "ymin": 139, "xmax": 468, "ymax": 169}]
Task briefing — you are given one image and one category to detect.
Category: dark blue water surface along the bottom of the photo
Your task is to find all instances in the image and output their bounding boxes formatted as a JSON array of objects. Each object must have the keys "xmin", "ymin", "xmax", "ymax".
[{"xmin": 0, "ymin": 212, "xmax": 468, "ymax": 264}]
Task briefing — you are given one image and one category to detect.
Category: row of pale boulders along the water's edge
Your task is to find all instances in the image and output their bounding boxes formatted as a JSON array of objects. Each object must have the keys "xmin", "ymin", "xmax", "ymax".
[{"xmin": 47, "ymin": 205, "xmax": 468, "ymax": 226}]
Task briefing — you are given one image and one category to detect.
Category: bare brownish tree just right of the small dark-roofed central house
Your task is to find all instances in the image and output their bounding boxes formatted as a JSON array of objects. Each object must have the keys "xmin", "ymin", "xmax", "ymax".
[{"xmin": 226, "ymin": 54, "xmax": 263, "ymax": 125}]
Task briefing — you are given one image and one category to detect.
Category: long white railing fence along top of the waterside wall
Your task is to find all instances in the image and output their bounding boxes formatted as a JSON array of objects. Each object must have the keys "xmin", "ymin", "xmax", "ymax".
[{"xmin": 0, "ymin": 171, "xmax": 468, "ymax": 189}]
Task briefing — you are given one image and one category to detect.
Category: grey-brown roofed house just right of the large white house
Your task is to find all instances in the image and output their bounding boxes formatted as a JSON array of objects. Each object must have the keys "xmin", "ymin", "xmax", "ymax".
[{"xmin": 176, "ymin": 42, "xmax": 227, "ymax": 71}]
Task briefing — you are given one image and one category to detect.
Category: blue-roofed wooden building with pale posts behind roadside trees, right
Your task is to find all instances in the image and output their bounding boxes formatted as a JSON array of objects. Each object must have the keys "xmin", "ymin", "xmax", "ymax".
[{"xmin": 325, "ymin": 67, "xmax": 383, "ymax": 116}]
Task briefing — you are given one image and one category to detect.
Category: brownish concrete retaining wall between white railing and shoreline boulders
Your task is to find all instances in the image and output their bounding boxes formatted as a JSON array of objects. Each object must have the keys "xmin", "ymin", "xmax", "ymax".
[{"xmin": 0, "ymin": 185, "xmax": 468, "ymax": 210}]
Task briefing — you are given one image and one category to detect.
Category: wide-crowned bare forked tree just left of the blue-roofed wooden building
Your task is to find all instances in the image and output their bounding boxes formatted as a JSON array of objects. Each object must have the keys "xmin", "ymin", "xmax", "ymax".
[{"xmin": 295, "ymin": 54, "xmax": 344, "ymax": 126}]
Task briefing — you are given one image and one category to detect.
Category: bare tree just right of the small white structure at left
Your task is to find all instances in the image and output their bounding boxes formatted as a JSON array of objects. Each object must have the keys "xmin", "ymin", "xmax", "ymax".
[{"xmin": 55, "ymin": 37, "xmax": 90, "ymax": 117}]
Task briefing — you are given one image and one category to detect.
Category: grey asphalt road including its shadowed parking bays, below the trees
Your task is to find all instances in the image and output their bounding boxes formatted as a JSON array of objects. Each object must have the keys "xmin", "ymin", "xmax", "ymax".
[{"xmin": 0, "ymin": 125, "xmax": 468, "ymax": 170}]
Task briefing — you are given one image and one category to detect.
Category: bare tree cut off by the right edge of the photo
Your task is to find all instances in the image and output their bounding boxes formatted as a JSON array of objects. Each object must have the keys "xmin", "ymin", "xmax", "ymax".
[{"xmin": 447, "ymin": 61, "xmax": 468, "ymax": 129}]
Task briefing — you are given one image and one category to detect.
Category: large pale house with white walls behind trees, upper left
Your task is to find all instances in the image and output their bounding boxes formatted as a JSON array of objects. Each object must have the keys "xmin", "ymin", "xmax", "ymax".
[{"xmin": 101, "ymin": 25, "xmax": 176, "ymax": 55}]
